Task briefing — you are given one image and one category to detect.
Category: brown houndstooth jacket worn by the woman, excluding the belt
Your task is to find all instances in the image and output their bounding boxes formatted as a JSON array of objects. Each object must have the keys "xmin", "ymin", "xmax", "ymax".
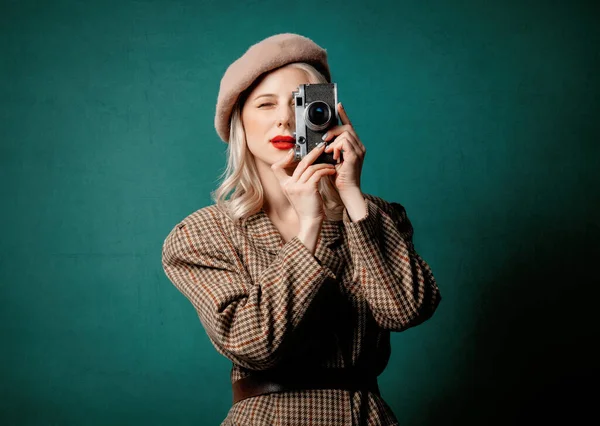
[{"xmin": 162, "ymin": 193, "xmax": 441, "ymax": 426}]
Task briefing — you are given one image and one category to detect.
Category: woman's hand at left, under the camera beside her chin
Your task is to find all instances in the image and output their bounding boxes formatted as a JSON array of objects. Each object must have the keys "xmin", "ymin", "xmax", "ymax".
[{"xmin": 271, "ymin": 143, "xmax": 336, "ymax": 226}]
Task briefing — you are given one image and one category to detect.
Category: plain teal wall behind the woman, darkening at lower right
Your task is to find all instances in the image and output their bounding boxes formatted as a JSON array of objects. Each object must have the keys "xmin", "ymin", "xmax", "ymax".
[{"xmin": 0, "ymin": 0, "xmax": 600, "ymax": 425}]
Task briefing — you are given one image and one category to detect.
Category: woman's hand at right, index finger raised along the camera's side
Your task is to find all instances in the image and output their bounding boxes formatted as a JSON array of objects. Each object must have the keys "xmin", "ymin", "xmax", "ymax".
[{"xmin": 324, "ymin": 103, "xmax": 367, "ymax": 195}]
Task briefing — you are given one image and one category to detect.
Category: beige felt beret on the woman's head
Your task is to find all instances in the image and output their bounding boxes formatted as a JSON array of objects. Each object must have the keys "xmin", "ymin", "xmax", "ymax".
[{"xmin": 215, "ymin": 33, "xmax": 331, "ymax": 143}]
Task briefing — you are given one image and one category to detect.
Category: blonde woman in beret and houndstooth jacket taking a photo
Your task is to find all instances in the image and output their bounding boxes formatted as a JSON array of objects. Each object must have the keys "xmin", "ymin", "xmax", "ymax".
[{"xmin": 163, "ymin": 34, "xmax": 441, "ymax": 425}]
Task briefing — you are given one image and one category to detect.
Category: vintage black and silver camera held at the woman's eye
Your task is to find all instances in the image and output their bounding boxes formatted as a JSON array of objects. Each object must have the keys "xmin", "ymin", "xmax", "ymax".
[{"xmin": 292, "ymin": 83, "xmax": 339, "ymax": 164}]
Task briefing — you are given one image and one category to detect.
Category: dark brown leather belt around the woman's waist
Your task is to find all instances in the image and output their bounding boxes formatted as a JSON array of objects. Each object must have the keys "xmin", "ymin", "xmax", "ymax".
[{"xmin": 232, "ymin": 368, "xmax": 379, "ymax": 404}]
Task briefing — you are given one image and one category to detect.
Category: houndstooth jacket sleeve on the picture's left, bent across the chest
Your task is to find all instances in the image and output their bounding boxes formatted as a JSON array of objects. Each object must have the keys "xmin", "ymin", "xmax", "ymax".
[{"xmin": 162, "ymin": 222, "xmax": 335, "ymax": 370}]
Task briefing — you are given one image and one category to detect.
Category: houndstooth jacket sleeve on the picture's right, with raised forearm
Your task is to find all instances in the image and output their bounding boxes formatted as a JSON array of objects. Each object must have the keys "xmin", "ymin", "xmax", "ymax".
[{"xmin": 343, "ymin": 194, "xmax": 441, "ymax": 331}]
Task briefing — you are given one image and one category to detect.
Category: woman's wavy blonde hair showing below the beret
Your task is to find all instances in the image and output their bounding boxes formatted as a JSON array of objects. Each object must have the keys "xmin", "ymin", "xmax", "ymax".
[{"xmin": 211, "ymin": 62, "xmax": 344, "ymax": 223}]
